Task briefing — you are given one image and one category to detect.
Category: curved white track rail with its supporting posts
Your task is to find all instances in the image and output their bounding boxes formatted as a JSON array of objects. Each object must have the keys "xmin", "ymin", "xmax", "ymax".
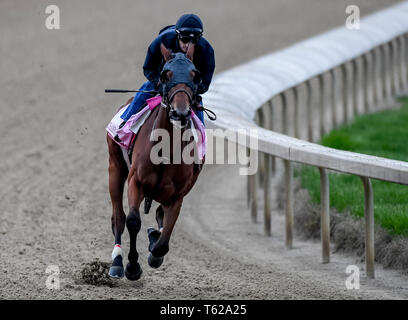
[{"xmin": 204, "ymin": 1, "xmax": 408, "ymax": 278}]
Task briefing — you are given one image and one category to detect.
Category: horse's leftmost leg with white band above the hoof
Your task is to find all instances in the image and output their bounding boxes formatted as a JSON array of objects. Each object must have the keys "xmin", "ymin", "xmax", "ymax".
[{"xmin": 107, "ymin": 136, "xmax": 128, "ymax": 278}]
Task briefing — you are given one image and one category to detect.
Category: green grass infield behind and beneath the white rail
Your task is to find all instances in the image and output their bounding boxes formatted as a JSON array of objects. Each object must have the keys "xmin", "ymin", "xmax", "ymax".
[{"xmin": 295, "ymin": 97, "xmax": 408, "ymax": 236}]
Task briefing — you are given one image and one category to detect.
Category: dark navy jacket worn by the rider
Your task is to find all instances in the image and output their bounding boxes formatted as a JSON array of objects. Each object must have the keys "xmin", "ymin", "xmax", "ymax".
[{"xmin": 143, "ymin": 26, "xmax": 215, "ymax": 94}]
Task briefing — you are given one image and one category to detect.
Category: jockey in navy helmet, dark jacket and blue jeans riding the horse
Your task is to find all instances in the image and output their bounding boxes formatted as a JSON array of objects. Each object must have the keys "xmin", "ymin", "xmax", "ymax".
[{"xmin": 121, "ymin": 14, "xmax": 215, "ymax": 126}]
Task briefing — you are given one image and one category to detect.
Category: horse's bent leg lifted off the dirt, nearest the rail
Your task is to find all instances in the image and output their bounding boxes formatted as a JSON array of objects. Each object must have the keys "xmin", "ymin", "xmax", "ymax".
[{"xmin": 148, "ymin": 199, "xmax": 183, "ymax": 268}]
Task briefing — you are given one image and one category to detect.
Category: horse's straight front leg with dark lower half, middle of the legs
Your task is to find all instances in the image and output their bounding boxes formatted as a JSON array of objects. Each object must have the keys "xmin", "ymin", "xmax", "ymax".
[{"xmin": 125, "ymin": 175, "xmax": 143, "ymax": 281}]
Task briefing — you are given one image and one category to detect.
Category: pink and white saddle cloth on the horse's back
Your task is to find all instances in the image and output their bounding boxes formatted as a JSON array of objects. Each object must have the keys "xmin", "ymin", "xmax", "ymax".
[{"xmin": 106, "ymin": 96, "xmax": 207, "ymax": 160}]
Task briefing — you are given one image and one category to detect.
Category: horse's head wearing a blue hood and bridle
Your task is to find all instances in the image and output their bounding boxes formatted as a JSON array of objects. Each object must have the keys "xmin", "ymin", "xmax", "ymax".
[{"xmin": 160, "ymin": 44, "xmax": 201, "ymax": 127}]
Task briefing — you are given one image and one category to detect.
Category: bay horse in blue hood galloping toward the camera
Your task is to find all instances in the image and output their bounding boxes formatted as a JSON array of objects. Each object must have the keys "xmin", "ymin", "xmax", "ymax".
[{"xmin": 107, "ymin": 44, "xmax": 205, "ymax": 281}]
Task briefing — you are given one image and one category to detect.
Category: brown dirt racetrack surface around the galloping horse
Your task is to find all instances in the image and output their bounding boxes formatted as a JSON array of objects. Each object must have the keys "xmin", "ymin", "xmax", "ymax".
[{"xmin": 0, "ymin": 0, "xmax": 408, "ymax": 299}]
